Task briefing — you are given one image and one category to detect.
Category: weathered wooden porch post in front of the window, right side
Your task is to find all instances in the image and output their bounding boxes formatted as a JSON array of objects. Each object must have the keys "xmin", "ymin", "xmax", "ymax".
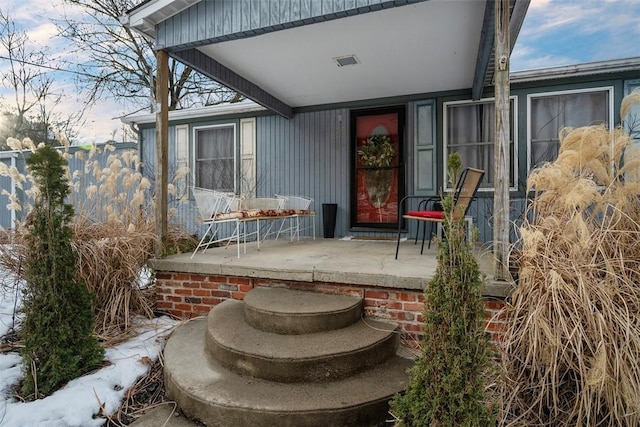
[{"xmin": 493, "ymin": 0, "xmax": 511, "ymax": 280}]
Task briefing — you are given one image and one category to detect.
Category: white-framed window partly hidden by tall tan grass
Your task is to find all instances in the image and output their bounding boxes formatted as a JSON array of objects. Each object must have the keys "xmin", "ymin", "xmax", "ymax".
[{"xmin": 528, "ymin": 88, "xmax": 613, "ymax": 170}]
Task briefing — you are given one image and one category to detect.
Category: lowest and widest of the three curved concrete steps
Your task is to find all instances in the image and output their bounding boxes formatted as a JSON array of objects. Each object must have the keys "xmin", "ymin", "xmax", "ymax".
[{"xmin": 164, "ymin": 318, "xmax": 412, "ymax": 427}]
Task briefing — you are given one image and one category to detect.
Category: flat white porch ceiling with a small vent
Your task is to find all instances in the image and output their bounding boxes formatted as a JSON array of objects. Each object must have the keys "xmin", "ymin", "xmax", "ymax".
[{"xmin": 199, "ymin": 0, "xmax": 485, "ymax": 107}]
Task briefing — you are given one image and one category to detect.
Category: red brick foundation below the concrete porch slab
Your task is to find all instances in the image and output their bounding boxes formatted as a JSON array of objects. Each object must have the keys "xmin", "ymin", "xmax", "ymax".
[{"xmin": 156, "ymin": 272, "xmax": 506, "ymax": 347}]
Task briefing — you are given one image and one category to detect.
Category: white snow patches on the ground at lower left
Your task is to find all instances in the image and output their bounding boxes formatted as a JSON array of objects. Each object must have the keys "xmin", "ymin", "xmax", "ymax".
[{"xmin": 0, "ymin": 271, "xmax": 178, "ymax": 427}]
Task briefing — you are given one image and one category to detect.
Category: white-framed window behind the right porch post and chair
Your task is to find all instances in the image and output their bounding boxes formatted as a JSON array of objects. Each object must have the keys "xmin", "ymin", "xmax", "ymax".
[{"xmin": 444, "ymin": 97, "xmax": 517, "ymax": 189}]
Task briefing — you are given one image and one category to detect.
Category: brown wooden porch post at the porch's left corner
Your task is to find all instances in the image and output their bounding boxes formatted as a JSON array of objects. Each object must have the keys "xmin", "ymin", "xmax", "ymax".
[{"xmin": 156, "ymin": 50, "xmax": 169, "ymax": 257}]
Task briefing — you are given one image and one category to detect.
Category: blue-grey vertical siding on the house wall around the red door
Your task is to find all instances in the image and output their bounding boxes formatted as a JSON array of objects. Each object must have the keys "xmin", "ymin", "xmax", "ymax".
[{"xmin": 140, "ymin": 103, "xmax": 508, "ymax": 241}]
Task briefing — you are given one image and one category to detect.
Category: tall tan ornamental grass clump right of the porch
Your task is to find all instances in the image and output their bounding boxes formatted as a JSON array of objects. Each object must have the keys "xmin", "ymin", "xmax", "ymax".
[{"xmin": 500, "ymin": 92, "xmax": 640, "ymax": 427}]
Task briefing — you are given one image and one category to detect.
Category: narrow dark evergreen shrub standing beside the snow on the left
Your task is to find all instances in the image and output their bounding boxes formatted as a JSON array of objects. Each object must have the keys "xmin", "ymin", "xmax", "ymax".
[{"xmin": 22, "ymin": 146, "xmax": 103, "ymax": 397}]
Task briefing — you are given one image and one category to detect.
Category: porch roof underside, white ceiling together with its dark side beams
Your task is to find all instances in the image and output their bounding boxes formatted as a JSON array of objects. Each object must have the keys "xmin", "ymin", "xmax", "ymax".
[{"xmin": 123, "ymin": 0, "xmax": 529, "ymax": 117}]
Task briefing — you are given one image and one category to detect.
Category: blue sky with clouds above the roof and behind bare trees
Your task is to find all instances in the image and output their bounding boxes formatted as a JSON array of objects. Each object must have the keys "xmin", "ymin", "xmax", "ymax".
[{"xmin": 0, "ymin": 0, "xmax": 640, "ymax": 143}]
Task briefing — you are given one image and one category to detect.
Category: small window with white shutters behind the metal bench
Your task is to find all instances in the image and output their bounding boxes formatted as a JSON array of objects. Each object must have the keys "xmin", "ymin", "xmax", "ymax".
[{"xmin": 194, "ymin": 125, "xmax": 236, "ymax": 192}]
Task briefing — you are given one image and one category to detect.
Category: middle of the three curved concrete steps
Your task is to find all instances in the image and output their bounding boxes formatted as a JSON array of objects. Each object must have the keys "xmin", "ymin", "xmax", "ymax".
[{"xmin": 205, "ymin": 300, "xmax": 399, "ymax": 383}]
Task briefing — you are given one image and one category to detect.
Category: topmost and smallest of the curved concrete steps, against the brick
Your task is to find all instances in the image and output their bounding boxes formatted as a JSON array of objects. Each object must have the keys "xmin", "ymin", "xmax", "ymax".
[{"xmin": 244, "ymin": 287, "xmax": 362, "ymax": 335}]
